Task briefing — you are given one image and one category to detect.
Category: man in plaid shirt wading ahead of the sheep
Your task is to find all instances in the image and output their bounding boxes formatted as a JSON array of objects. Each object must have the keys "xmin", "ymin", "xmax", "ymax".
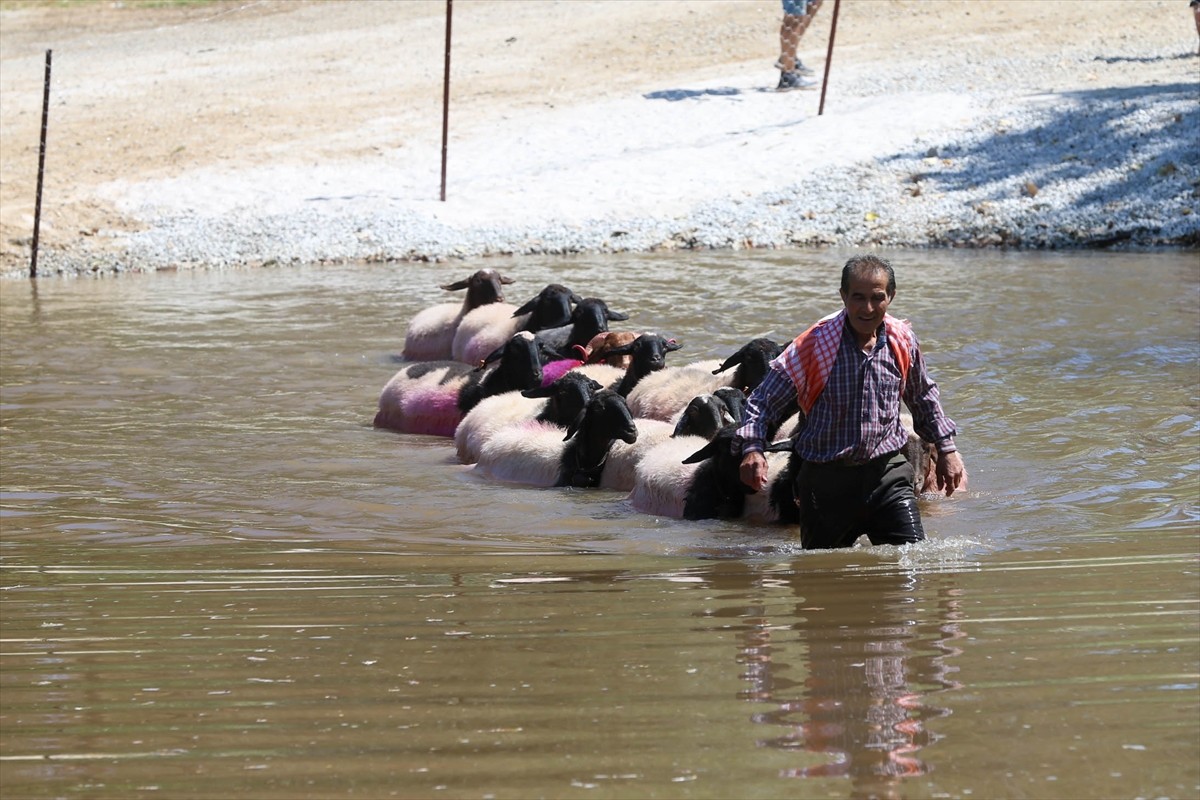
[{"xmin": 733, "ymin": 255, "xmax": 966, "ymax": 548}]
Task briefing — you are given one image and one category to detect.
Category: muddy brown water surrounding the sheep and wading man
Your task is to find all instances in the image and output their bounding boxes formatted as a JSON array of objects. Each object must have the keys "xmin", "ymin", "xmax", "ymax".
[{"xmin": 0, "ymin": 252, "xmax": 1200, "ymax": 798}]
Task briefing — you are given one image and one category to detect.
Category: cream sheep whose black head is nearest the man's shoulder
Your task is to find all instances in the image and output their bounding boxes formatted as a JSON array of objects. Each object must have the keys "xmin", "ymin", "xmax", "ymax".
[{"xmin": 629, "ymin": 338, "xmax": 782, "ymax": 420}]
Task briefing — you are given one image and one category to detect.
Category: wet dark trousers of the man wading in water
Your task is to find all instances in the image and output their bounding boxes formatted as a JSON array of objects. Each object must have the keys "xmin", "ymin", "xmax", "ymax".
[{"xmin": 796, "ymin": 453, "xmax": 925, "ymax": 549}]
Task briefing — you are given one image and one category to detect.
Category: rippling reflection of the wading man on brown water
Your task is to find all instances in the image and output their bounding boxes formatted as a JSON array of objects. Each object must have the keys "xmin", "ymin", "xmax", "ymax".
[{"xmin": 709, "ymin": 570, "xmax": 965, "ymax": 798}]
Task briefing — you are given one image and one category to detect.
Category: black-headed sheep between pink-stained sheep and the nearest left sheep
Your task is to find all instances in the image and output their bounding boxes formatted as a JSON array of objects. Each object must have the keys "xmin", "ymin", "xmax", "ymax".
[{"xmin": 454, "ymin": 372, "xmax": 600, "ymax": 464}]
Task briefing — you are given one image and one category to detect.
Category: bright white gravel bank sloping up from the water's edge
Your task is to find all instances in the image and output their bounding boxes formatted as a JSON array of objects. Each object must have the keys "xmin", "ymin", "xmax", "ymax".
[{"xmin": 11, "ymin": 23, "xmax": 1200, "ymax": 273}]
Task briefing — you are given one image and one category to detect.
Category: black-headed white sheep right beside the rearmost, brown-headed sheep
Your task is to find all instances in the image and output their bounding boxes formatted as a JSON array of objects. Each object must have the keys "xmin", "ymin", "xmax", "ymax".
[{"xmin": 450, "ymin": 283, "xmax": 581, "ymax": 365}]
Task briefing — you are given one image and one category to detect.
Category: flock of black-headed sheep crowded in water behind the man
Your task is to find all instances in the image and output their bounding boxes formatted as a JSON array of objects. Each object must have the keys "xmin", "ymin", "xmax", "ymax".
[{"xmin": 374, "ymin": 269, "xmax": 929, "ymax": 524}]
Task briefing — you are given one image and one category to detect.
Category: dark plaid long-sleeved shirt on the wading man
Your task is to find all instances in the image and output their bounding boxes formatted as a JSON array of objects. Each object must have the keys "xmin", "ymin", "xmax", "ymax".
[{"xmin": 733, "ymin": 316, "xmax": 956, "ymax": 463}]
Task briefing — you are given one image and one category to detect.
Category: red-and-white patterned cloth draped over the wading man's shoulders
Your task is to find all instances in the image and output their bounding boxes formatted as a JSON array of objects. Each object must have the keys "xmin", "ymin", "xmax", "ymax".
[{"xmin": 774, "ymin": 308, "xmax": 913, "ymax": 414}]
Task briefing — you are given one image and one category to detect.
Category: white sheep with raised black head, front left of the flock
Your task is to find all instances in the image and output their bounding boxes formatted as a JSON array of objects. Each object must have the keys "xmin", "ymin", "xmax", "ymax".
[{"xmin": 474, "ymin": 389, "xmax": 637, "ymax": 488}]
